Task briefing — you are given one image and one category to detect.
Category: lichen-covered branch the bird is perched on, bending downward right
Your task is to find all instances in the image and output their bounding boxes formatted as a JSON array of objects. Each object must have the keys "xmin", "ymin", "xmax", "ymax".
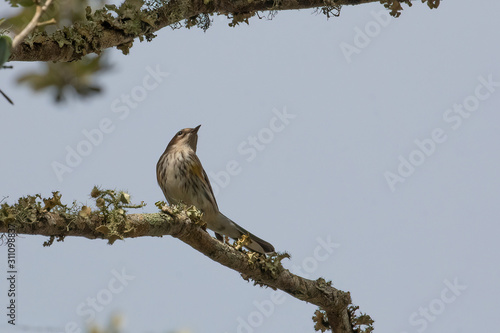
[{"xmin": 0, "ymin": 188, "xmax": 372, "ymax": 333}]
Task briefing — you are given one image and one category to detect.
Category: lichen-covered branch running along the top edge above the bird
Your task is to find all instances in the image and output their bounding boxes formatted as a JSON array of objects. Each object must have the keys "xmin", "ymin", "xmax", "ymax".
[{"xmin": 5, "ymin": 0, "xmax": 439, "ymax": 62}]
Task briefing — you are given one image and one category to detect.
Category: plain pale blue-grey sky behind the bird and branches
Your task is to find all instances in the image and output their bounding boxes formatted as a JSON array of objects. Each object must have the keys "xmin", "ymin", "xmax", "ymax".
[{"xmin": 0, "ymin": 0, "xmax": 500, "ymax": 333}]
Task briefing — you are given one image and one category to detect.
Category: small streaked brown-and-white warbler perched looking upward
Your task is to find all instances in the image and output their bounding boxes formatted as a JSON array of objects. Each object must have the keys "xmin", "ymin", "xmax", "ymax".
[{"xmin": 156, "ymin": 125, "xmax": 274, "ymax": 253}]
